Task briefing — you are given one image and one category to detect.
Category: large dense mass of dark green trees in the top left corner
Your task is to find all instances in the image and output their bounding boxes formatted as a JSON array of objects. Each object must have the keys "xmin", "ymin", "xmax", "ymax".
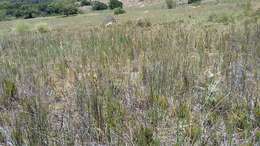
[{"xmin": 0, "ymin": 0, "xmax": 78, "ymax": 20}]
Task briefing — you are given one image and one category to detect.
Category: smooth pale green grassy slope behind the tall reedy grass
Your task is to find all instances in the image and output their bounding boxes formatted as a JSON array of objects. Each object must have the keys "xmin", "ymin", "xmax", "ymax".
[{"xmin": 0, "ymin": 2, "xmax": 256, "ymax": 34}]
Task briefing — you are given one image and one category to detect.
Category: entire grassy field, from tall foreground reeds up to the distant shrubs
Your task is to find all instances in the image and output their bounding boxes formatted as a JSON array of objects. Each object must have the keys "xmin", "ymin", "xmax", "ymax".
[{"xmin": 0, "ymin": 1, "xmax": 260, "ymax": 146}]
